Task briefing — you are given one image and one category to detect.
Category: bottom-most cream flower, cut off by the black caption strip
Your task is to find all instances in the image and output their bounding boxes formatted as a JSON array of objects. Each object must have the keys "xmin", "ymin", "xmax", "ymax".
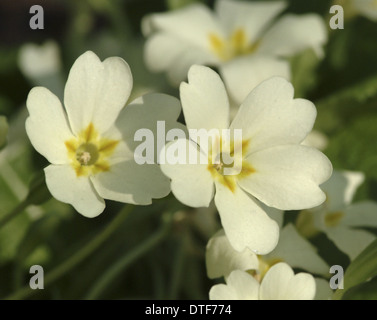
[{"xmin": 209, "ymin": 262, "xmax": 316, "ymax": 300}]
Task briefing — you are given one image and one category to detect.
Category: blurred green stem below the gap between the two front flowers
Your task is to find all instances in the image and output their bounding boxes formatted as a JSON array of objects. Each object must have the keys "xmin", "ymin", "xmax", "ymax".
[{"xmin": 85, "ymin": 214, "xmax": 171, "ymax": 300}]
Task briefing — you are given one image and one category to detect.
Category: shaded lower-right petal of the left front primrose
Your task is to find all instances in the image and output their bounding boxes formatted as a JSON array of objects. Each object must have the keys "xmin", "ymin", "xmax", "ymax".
[{"xmin": 91, "ymin": 159, "xmax": 170, "ymax": 205}]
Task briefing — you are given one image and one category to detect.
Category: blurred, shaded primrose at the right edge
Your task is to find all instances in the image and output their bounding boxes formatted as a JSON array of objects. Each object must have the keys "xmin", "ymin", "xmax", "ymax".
[{"xmin": 310, "ymin": 171, "xmax": 377, "ymax": 260}]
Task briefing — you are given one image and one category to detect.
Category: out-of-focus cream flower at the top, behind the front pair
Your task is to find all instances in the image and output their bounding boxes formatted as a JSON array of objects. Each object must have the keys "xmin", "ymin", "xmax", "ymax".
[{"xmin": 142, "ymin": 0, "xmax": 327, "ymax": 103}]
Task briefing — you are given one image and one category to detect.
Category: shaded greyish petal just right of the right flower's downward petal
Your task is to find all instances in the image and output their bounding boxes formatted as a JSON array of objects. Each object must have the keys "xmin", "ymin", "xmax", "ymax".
[{"xmin": 267, "ymin": 224, "xmax": 329, "ymax": 276}]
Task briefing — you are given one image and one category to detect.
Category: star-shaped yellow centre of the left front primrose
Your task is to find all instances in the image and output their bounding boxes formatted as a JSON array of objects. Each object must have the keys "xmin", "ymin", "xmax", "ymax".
[{"xmin": 65, "ymin": 123, "xmax": 119, "ymax": 177}]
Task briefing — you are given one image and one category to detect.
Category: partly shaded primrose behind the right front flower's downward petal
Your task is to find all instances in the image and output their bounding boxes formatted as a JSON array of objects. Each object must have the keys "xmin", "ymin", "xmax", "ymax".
[{"xmin": 206, "ymin": 224, "xmax": 329, "ymax": 280}]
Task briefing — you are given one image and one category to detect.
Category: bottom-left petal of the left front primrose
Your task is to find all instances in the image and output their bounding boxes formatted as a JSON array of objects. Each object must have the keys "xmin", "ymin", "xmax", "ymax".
[{"xmin": 45, "ymin": 165, "xmax": 105, "ymax": 218}]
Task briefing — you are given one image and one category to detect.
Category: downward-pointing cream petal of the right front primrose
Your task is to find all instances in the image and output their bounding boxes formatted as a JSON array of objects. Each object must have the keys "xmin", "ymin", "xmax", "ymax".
[{"xmin": 215, "ymin": 182, "xmax": 279, "ymax": 254}]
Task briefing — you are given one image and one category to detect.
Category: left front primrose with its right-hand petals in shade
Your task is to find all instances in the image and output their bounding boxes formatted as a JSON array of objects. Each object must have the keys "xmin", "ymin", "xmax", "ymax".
[{"xmin": 26, "ymin": 51, "xmax": 176, "ymax": 217}]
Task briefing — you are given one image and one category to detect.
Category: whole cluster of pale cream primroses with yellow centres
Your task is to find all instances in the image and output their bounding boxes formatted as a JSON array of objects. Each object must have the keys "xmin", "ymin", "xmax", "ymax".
[{"xmin": 26, "ymin": 0, "xmax": 377, "ymax": 299}]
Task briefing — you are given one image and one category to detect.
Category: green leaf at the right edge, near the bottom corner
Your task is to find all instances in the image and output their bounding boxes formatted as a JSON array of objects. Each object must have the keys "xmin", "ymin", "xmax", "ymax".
[{"xmin": 333, "ymin": 240, "xmax": 377, "ymax": 300}]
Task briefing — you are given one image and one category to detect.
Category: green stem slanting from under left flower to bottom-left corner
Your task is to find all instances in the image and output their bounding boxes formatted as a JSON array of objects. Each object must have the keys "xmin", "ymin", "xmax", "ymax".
[{"xmin": 5, "ymin": 205, "xmax": 133, "ymax": 300}]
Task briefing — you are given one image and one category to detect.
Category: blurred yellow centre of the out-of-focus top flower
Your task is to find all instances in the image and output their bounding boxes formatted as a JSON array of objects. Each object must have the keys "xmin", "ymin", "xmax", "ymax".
[{"xmin": 209, "ymin": 28, "xmax": 259, "ymax": 62}]
